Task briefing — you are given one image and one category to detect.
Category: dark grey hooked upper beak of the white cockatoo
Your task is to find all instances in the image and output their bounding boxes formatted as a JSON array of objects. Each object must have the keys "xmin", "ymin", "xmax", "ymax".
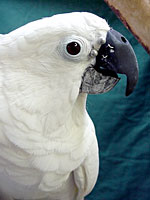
[{"xmin": 94, "ymin": 29, "xmax": 138, "ymax": 96}]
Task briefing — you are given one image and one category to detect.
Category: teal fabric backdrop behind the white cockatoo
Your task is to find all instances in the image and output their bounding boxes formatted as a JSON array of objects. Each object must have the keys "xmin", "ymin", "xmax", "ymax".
[{"xmin": 0, "ymin": 0, "xmax": 150, "ymax": 200}]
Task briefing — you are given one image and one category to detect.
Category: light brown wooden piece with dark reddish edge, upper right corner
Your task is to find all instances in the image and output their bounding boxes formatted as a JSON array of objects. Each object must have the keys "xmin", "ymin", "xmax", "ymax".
[{"xmin": 104, "ymin": 0, "xmax": 150, "ymax": 54}]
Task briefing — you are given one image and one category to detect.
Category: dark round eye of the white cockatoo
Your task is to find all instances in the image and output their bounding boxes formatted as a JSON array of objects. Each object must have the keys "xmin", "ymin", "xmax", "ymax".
[{"xmin": 66, "ymin": 42, "xmax": 81, "ymax": 55}]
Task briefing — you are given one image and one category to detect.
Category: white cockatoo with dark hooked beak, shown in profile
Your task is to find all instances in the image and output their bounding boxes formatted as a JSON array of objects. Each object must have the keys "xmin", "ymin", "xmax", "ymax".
[{"xmin": 0, "ymin": 12, "xmax": 138, "ymax": 200}]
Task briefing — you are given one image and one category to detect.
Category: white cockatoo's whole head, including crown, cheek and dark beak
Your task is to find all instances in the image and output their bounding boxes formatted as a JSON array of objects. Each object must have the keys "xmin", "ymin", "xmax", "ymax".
[{"xmin": 1, "ymin": 12, "xmax": 138, "ymax": 115}]
